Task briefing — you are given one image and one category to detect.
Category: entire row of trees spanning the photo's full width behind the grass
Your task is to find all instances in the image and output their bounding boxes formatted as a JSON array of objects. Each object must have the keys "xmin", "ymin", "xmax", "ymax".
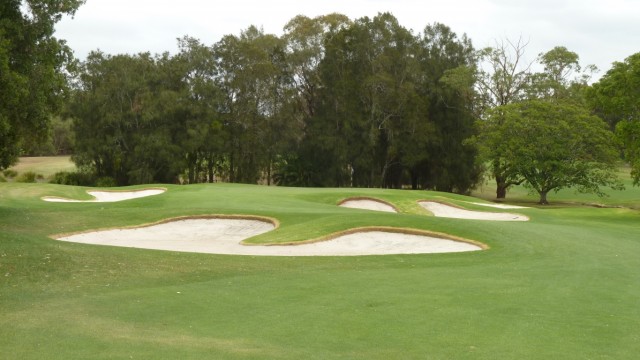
[{"xmin": 0, "ymin": 0, "xmax": 640, "ymax": 203}]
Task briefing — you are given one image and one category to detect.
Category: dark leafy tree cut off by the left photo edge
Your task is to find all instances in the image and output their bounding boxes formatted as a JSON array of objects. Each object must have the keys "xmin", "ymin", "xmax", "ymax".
[{"xmin": 0, "ymin": 0, "xmax": 84, "ymax": 169}]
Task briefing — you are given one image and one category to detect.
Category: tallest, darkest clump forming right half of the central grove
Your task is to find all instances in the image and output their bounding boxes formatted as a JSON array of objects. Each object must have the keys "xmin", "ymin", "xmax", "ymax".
[{"xmin": 291, "ymin": 14, "xmax": 479, "ymax": 192}]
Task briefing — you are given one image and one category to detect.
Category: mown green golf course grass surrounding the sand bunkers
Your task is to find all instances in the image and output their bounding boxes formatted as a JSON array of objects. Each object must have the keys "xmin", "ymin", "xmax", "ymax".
[{"xmin": 0, "ymin": 183, "xmax": 640, "ymax": 359}]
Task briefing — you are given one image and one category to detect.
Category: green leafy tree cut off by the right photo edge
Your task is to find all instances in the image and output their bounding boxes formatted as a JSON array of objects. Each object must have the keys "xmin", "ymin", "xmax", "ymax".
[{"xmin": 587, "ymin": 53, "xmax": 640, "ymax": 185}]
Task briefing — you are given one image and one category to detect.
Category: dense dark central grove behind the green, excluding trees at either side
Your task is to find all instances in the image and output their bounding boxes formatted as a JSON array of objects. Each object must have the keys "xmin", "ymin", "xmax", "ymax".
[{"xmin": 70, "ymin": 14, "xmax": 480, "ymax": 192}]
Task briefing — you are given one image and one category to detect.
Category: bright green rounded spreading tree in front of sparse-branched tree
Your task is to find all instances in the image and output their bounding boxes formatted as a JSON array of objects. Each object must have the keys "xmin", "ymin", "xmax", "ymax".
[{"xmin": 485, "ymin": 100, "xmax": 622, "ymax": 204}]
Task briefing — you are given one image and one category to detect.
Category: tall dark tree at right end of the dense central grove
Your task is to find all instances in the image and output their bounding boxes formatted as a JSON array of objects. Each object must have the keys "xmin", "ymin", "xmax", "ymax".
[{"xmin": 414, "ymin": 23, "xmax": 480, "ymax": 193}]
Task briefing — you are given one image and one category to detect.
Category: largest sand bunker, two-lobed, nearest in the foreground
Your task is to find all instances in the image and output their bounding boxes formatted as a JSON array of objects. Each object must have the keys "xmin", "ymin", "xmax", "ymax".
[{"xmin": 57, "ymin": 218, "xmax": 483, "ymax": 256}]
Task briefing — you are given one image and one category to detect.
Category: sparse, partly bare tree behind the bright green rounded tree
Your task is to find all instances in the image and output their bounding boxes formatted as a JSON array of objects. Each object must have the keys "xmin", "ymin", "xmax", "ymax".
[{"xmin": 476, "ymin": 40, "xmax": 595, "ymax": 199}]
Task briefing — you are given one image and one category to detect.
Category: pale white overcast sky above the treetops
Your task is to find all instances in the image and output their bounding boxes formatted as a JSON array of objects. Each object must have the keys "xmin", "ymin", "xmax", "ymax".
[{"xmin": 56, "ymin": 0, "xmax": 640, "ymax": 77}]
